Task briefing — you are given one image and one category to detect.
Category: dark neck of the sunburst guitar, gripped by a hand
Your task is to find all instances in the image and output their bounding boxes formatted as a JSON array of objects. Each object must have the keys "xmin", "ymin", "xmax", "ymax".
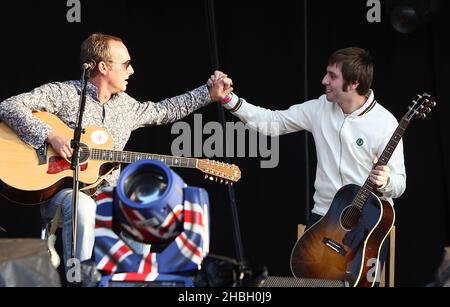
[{"xmin": 352, "ymin": 116, "xmax": 410, "ymax": 209}]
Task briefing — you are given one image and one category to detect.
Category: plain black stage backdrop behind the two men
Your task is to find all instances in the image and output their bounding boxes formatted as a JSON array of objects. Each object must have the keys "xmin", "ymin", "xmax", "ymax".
[{"xmin": 0, "ymin": 0, "xmax": 450, "ymax": 286}]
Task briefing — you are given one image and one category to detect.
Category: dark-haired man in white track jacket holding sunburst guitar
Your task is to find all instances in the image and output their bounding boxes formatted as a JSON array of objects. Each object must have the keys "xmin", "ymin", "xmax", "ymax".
[{"xmin": 208, "ymin": 47, "xmax": 406, "ymax": 226}]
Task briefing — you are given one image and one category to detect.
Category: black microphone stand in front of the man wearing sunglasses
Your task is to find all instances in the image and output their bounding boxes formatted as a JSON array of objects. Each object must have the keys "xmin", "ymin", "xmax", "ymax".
[{"xmin": 71, "ymin": 66, "xmax": 90, "ymax": 259}]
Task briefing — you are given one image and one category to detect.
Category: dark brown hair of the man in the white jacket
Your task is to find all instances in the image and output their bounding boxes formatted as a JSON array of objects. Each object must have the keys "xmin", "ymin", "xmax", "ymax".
[{"xmin": 328, "ymin": 47, "xmax": 373, "ymax": 95}]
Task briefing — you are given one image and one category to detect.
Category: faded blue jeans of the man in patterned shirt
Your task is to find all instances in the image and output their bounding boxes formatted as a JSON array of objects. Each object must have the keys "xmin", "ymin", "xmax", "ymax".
[{"xmin": 41, "ymin": 189, "xmax": 97, "ymax": 267}]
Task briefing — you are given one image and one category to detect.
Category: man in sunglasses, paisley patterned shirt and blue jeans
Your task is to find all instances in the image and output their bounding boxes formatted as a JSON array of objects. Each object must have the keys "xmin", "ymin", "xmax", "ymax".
[{"xmin": 0, "ymin": 33, "xmax": 232, "ymax": 274}]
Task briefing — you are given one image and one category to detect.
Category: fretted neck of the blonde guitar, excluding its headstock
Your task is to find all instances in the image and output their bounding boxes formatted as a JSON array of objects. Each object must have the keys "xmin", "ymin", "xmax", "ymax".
[{"xmin": 90, "ymin": 148, "xmax": 198, "ymax": 168}]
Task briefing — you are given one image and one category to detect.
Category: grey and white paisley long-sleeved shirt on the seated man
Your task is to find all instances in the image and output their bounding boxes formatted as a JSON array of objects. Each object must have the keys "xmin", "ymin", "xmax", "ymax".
[{"xmin": 0, "ymin": 81, "xmax": 211, "ymax": 185}]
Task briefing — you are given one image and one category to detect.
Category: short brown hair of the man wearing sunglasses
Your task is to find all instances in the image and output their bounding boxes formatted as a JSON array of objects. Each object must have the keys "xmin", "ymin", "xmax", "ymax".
[{"xmin": 80, "ymin": 33, "xmax": 122, "ymax": 69}]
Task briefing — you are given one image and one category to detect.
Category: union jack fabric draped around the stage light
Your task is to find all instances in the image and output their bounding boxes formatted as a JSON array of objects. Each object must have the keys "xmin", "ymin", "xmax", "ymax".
[{"xmin": 94, "ymin": 187, "xmax": 209, "ymax": 281}]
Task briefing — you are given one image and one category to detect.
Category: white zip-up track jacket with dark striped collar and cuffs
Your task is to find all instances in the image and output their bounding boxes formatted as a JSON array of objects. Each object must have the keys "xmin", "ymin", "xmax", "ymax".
[{"xmin": 224, "ymin": 91, "xmax": 406, "ymax": 215}]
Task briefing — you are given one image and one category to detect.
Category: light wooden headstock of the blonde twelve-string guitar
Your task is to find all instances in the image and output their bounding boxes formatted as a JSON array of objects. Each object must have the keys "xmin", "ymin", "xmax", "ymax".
[{"xmin": 197, "ymin": 159, "xmax": 241, "ymax": 184}]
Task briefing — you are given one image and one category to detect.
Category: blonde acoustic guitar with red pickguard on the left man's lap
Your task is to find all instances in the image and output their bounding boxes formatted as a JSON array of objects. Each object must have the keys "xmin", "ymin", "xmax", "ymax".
[{"xmin": 0, "ymin": 112, "xmax": 241, "ymax": 205}]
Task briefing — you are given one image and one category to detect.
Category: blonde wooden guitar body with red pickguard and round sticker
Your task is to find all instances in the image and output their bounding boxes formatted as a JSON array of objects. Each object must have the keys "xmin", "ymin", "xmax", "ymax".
[{"xmin": 0, "ymin": 112, "xmax": 113, "ymax": 204}]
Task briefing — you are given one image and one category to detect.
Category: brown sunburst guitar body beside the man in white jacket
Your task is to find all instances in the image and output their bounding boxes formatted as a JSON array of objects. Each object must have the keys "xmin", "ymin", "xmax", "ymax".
[{"xmin": 291, "ymin": 185, "xmax": 395, "ymax": 287}]
